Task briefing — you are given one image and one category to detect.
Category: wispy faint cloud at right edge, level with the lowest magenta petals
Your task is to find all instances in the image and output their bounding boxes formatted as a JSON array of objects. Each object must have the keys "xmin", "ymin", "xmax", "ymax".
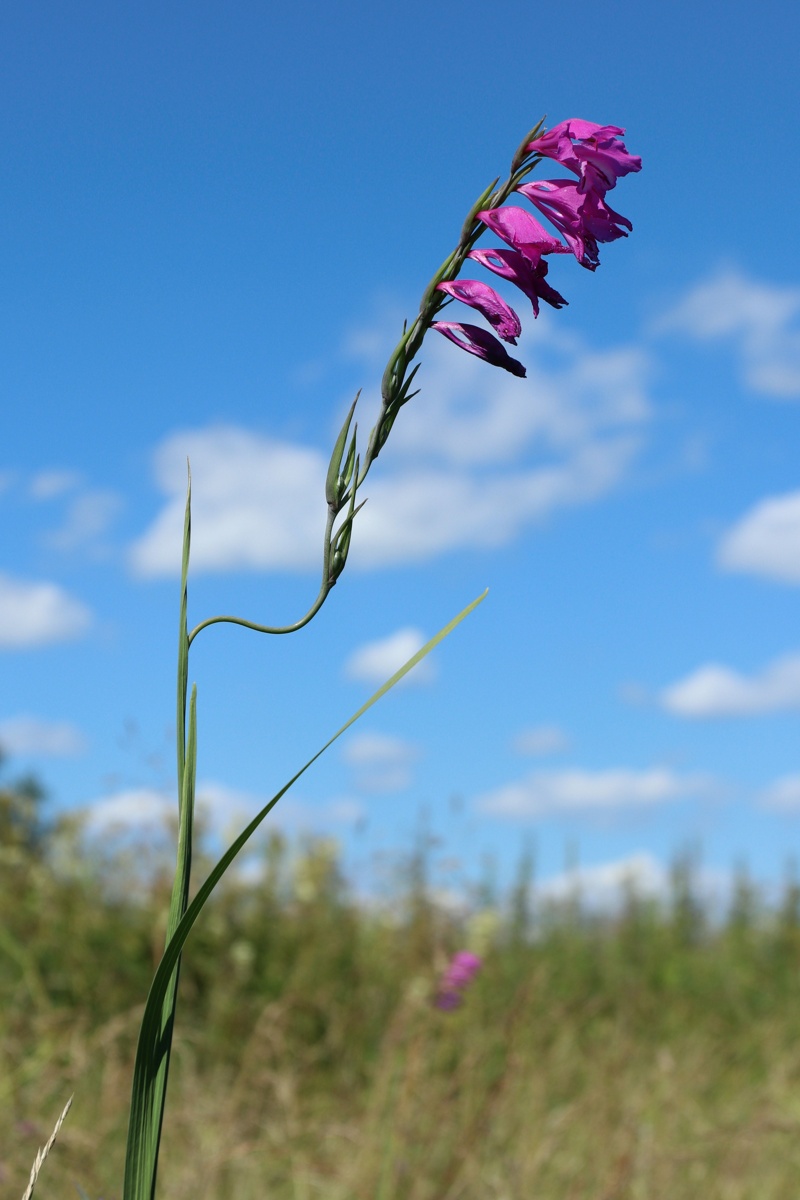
[{"xmin": 656, "ymin": 269, "xmax": 800, "ymax": 400}]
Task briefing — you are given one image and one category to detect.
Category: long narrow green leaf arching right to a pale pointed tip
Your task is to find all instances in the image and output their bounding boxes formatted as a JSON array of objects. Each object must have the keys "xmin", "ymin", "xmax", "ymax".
[{"xmin": 122, "ymin": 592, "xmax": 487, "ymax": 1200}]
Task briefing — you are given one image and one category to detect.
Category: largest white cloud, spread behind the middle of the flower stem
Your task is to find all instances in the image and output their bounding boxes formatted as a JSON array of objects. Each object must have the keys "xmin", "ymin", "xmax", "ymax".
[{"xmin": 131, "ymin": 317, "xmax": 650, "ymax": 576}]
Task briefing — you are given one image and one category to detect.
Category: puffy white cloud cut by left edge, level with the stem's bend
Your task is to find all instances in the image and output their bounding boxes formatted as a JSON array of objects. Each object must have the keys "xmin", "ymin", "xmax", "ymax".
[{"xmin": 0, "ymin": 574, "xmax": 91, "ymax": 649}]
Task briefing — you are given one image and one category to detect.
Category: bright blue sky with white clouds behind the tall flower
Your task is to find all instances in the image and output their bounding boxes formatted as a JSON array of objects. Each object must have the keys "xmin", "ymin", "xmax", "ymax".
[{"xmin": 0, "ymin": 0, "xmax": 800, "ymax": 902}]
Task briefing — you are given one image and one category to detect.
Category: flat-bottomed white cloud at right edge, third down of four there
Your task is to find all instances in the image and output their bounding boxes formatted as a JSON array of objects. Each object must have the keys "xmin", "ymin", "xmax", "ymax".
[{"xmin": 660, "ymin": 654, "xmax": 800, "ymax": 718}]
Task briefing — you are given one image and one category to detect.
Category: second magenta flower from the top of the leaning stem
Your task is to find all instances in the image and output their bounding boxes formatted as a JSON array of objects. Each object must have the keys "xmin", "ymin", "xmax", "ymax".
[{"xmin": 518, "ymin": 179, "xmax": 633, "ymax": 271}]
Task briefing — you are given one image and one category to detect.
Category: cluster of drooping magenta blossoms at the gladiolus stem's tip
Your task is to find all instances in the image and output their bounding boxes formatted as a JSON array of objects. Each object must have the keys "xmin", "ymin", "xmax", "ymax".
[{"xmin": 423, "ymin": 118, "xmax": 642, "ymax": 378}]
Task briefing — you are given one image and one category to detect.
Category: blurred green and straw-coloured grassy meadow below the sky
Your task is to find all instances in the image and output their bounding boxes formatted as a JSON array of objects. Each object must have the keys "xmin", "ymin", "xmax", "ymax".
[{"xmin": 0, "ymin": 782, "xmax": 800, "ymax": 1200}]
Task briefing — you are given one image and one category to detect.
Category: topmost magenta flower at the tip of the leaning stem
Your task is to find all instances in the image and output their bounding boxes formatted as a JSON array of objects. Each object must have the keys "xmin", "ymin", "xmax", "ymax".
[{"xmin": 528, "ymin": 116, "xmax": 642, "ymax": 194}]
